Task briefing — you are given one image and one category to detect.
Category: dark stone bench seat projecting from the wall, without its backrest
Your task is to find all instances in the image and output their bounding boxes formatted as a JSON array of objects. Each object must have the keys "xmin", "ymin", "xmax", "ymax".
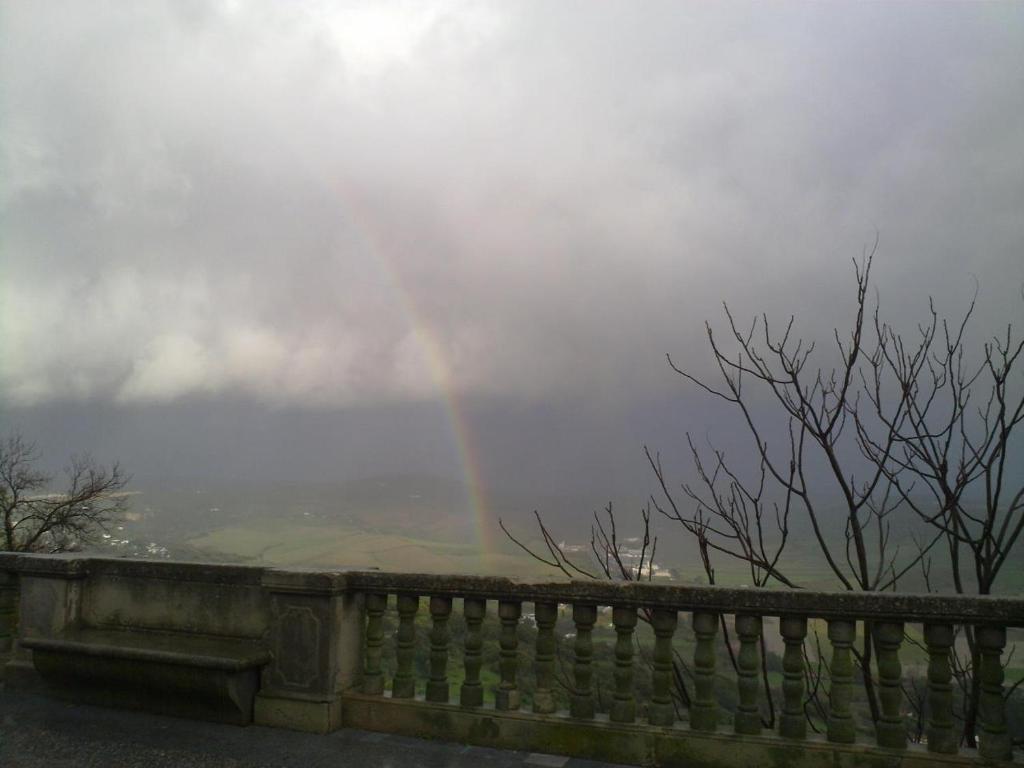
[{"xmin": 22, "ymin": 629, "xmax": 270, "ymax": 725}]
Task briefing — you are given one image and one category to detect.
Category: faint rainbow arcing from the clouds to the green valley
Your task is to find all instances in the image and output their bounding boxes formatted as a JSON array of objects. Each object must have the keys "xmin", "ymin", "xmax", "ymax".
[{"xmin": 332, "ymin": 182, "xmax": 497, "ymax": 563}]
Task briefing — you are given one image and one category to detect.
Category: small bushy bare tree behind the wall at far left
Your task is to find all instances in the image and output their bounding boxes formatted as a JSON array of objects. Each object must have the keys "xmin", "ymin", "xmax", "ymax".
[{"xmin": 0, "ymin": 433, "xmax": 129, "ymax": 552}]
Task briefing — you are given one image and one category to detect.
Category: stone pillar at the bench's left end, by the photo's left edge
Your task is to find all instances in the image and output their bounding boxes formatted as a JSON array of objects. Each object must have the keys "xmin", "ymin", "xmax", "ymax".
[{"xmin": 3, "ymin": 555, "xmax": 88, "ymax": 688}]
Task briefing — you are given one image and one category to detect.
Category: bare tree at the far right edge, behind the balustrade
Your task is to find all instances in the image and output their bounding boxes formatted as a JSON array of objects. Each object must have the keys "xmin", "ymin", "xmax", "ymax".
[{"xmin": 855, "ymin": 294, "xmax": 1024, "ymax": 746}]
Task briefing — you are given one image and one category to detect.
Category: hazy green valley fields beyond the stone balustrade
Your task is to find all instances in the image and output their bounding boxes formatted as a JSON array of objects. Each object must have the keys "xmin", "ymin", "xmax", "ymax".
[{"xmin": 108, "ymin": 475, "xmax": 1024, "ymax": 594}]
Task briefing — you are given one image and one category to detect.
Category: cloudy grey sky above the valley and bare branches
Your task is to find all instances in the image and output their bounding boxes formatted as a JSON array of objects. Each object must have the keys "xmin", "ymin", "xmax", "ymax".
[{"xmin": 0, "ymin": 0, "xmax": 1024, "ymax": 495}]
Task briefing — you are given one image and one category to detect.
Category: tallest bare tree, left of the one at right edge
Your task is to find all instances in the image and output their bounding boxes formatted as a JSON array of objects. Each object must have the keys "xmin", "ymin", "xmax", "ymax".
[{"xmin": 659, "ymin": 243, "xmax": 921, "ymax": 720}]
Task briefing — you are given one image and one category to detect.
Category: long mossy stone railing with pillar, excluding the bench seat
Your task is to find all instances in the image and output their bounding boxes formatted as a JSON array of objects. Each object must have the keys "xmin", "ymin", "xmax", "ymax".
[{"xmin": 0, "ymin": 554, "xmax": 1024, "ymax": 768}]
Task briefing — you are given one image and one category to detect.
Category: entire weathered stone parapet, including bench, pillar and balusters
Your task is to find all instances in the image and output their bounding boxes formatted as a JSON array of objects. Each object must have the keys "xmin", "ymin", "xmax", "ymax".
[{"xmin": 0, "ymin": 553, "xmax": 1024, "ymax": 768}]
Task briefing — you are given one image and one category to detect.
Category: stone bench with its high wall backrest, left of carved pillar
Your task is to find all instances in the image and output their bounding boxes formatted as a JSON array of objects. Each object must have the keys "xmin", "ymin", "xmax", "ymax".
[{"xmin": 0, "ymin": 553, "xmax": 271, "ymax": 725}]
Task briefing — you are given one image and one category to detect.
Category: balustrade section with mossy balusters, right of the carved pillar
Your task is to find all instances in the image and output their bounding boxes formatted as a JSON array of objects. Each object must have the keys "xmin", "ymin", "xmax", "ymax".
[{"xmin": 348, "ymin": 572, "xmax": 1024, "ymax": 765}]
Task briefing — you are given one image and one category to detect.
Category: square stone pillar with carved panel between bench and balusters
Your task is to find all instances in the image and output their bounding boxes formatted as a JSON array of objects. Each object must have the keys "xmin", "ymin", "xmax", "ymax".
[{"xmin": 253, "ymin": 570, "xmax": 364, "ymax": 733}]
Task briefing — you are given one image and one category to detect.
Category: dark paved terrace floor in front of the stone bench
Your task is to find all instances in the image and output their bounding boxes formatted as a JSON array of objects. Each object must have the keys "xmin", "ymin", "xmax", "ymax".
[{"xmin": 0, "ymin": 687, "xmax": 630, "ymax": 768}]
